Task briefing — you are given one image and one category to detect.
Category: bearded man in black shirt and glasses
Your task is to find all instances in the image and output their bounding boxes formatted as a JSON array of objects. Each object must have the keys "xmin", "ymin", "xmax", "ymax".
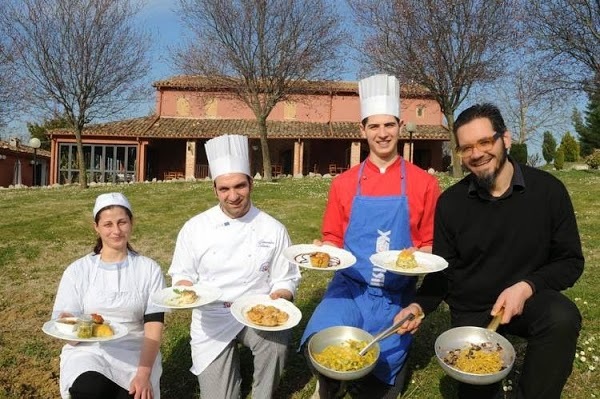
[{"xmin": 396, "ymin": 104, "xmax": 584, "ymax": 399}]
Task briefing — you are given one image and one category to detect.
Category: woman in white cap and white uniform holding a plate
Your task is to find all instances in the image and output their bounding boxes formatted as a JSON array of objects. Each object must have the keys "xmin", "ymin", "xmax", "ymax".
[{"xmin": 52, "ymin": 193, "xmax": 165, "ymax": 399}]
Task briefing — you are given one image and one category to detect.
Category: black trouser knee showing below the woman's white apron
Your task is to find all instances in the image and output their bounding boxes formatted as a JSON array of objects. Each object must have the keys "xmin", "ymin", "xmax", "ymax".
[{"xmin": 69, "ymin": 371, "xmax": 133, "ymax": 399}]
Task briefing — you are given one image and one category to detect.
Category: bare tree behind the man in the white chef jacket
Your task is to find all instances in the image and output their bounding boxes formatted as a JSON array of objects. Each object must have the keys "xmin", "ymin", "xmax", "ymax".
[{"xmin": 175, "ymin": 0, "xmax": 345, "ymax": 180}]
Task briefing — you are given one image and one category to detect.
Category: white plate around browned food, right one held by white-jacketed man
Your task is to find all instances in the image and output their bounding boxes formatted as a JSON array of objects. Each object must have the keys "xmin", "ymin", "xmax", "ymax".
[{"xmin": 230, "ymin": 295, "xmax": 302, "ymax": 331}]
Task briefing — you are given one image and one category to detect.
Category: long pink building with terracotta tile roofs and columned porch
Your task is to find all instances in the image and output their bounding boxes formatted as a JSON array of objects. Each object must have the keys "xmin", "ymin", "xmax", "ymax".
[{"xmin": 50, "ymin": 76, "xmax": 448, "ymax": 184}]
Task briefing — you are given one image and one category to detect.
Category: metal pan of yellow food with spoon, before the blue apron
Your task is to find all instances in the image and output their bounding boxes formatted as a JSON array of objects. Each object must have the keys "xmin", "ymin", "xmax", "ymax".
[{"xmin": 308, "ymin": 326, "xmax": 380, "ymax": 381}]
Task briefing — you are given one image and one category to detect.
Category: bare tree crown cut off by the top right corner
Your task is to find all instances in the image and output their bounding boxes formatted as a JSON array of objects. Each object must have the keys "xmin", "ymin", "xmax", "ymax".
[{"xmin": 527, "ymin": 0, "xmax": 600, "ymax": 93}]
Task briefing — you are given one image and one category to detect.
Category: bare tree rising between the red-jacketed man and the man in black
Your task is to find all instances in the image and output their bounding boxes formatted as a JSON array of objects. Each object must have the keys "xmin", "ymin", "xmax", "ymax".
[{"xmin": 348, "ymin": 0, "xmax": 519, "ymax": 176}]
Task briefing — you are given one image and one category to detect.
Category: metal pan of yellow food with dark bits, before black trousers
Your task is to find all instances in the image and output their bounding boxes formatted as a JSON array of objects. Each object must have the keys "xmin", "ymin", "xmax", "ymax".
[{"xmin": 435, "ymin": 312, "xmax": 515, "ymax": 385}]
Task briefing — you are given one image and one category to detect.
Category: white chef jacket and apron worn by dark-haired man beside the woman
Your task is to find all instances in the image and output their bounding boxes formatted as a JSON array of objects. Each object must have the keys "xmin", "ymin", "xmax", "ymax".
[{"xmin": 168, "ymin": 205, "xmax": 300, "ymax": 375}]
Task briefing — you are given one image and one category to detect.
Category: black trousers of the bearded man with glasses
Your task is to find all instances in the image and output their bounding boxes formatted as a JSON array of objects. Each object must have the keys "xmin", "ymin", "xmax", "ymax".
[{"xmin": 452, "ymin": 290, "xmax": 581, "ymax": 399}]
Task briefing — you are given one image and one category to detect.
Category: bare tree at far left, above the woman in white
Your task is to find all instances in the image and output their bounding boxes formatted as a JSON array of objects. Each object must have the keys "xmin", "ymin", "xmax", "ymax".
[{"xmin": 3, "ymin": 0, "xmax": 150, "ymax": 187}]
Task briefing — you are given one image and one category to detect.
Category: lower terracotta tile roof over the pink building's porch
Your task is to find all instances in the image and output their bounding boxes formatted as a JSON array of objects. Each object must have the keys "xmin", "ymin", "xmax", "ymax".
[{"xmin": 51, "ymin": 117, "xmax": 448, "ymax": 140}]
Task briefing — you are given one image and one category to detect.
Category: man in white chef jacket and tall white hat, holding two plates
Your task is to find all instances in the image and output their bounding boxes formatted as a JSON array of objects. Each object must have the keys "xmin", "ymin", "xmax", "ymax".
[{"xmin": 169, "ymin": 135, "xmax": 300, "ymax": 399}]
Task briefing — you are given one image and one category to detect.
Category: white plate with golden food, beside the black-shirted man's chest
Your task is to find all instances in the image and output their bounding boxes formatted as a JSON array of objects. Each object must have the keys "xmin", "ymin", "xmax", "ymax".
[{"xmin": 369, "ymin": 249, "xmax": 448, "ymax": 276}]
